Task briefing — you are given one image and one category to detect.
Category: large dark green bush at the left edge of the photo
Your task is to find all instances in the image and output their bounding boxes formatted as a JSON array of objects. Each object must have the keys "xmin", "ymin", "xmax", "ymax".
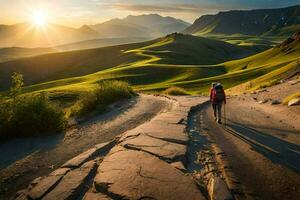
[{"xmin": 0, "ymin": 94, "xmax": 66, "ymax": 137}]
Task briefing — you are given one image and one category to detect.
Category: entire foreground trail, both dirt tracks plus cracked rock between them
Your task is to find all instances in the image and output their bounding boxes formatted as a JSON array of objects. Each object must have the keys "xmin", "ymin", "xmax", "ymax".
[{"xmin": 0, "ymin": 84, "xmax": 300, "ymax": 200}]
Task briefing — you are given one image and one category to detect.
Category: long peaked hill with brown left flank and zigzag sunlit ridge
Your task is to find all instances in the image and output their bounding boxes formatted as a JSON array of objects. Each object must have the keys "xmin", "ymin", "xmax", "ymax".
[{"xmin": 0, "ymin": 34, "xmax": 254, "ymax": 90}]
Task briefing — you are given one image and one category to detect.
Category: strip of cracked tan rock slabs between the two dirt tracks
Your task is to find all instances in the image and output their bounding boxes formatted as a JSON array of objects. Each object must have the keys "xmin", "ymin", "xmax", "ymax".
[{"xmin": 16, "ymin": 97, "xmax": 207, "ymax": 200}]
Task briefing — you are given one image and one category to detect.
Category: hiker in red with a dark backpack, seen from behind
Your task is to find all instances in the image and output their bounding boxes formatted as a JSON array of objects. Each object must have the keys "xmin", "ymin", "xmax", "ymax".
[{"xmin": 210, "ymin": 83, "xmax": 226, "ymax": 124}]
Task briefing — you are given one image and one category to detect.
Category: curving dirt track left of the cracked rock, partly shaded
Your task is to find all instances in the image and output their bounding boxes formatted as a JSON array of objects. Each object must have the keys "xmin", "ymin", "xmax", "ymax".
[{"xmin": 0, "ymin": 95, "xmax": 173, "ymax": 199}]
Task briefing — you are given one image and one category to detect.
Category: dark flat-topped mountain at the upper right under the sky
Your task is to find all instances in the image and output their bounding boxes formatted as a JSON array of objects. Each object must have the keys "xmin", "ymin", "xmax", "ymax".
[{"xmin": 184, "ymin": 5, "xmax": 300, "ymax": 36}]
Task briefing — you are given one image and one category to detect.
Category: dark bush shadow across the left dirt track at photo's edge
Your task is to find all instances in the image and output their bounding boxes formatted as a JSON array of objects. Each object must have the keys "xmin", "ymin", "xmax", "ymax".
[{"xmin": 0, "ymin": 134, "xmax": 64, "ymax": 170}]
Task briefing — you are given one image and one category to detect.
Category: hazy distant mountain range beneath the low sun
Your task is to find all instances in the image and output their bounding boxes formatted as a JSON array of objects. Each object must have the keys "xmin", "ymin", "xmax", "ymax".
[{"xmin": 0, "ymin": 14, "xmax": 190, "ymax": 48}]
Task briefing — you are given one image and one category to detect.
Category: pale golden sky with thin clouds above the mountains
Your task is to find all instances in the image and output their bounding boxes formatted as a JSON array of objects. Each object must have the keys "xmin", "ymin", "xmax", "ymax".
[{"xmin": 0, "ymin": 0, "xmax": 300, "ymax": 27}]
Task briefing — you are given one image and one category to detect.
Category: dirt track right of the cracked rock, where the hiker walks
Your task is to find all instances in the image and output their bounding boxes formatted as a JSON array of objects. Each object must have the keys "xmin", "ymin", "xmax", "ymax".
[{"xmin": 201, "ymin": 97, "xmax": 300, "ymax": 200}]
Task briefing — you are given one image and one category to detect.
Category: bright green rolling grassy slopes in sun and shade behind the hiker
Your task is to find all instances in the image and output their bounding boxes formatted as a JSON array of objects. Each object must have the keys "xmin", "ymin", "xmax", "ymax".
[{"xmin": 1, "ymin": 35, "xmax": 300, "ymax": 104}]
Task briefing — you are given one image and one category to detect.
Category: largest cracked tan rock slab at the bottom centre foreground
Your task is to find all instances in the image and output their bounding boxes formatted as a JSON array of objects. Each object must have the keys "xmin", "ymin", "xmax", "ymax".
[{"xmin": 94, "ymin": 146, "xmax": 205, "ymax": 200}]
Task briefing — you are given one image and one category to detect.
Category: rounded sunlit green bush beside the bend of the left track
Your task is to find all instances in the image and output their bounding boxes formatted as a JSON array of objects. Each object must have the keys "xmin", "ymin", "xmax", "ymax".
[{"xmin": 75, "ymin": 81, "xmax": 136, "ymax": 116}]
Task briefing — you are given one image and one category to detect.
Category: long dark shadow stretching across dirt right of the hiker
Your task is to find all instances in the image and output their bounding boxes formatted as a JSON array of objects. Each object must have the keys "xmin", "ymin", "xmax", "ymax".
[{"xmin": 225, "ymin": 121, "xmax": 300, "ymax": 174}]
